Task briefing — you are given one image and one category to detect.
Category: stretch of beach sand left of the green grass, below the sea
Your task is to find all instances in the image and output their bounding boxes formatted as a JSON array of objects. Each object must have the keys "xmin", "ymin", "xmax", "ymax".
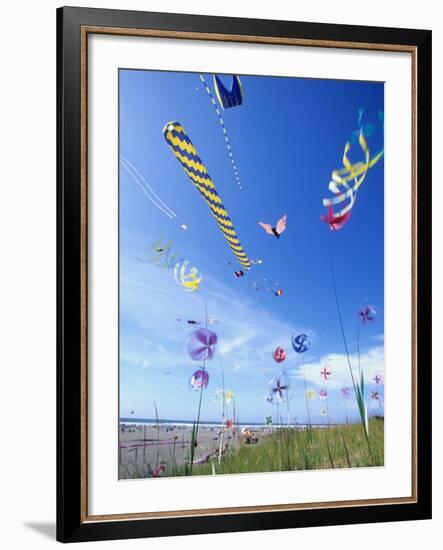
[{"xmin": 119, "ymin": 424, "xmax": 270, "ymax": 479}]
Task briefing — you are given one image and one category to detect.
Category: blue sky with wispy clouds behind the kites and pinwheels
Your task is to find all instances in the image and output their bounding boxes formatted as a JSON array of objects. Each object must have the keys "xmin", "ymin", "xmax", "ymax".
[{"xmin": 119, "ymin": 70, "xmax": 384, "ymax": 422}]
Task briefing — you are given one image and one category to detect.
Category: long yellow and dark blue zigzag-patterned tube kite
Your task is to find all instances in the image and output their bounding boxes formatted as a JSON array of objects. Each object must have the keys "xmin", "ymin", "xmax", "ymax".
[{"xmin": 163, "ymin": 122, "xmax": 252, "ymax": 269}]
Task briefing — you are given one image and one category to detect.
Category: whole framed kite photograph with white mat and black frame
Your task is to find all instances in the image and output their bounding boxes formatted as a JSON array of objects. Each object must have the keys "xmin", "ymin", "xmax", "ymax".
[{"xmin": 57, "ymin": 8, "xmax": 431, "ymax": 542}]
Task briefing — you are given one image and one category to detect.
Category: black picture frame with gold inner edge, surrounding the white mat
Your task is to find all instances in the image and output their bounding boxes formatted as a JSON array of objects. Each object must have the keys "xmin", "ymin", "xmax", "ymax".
[{"xmin": 57, "ymin": 7, "xmax": 432, "ymax": 542}]
